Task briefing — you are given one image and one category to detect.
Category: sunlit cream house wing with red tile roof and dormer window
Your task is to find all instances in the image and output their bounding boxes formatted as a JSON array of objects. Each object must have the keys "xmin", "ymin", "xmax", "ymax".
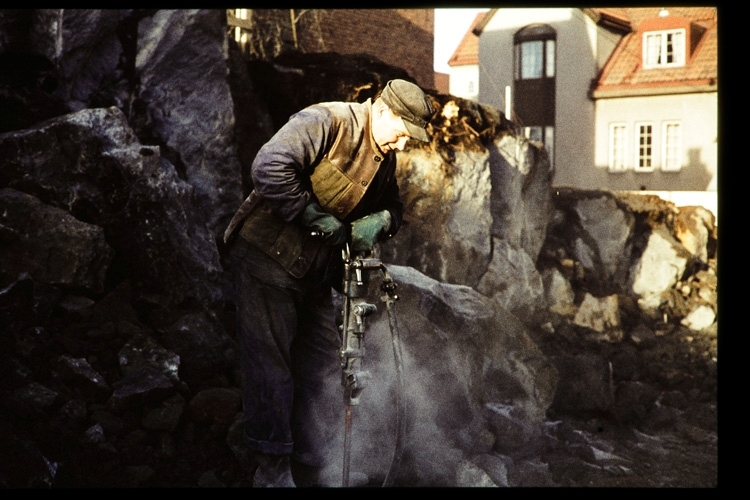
[{"xmin": 592, "ymin": 7, "xmax": 718, "ymax": 195}]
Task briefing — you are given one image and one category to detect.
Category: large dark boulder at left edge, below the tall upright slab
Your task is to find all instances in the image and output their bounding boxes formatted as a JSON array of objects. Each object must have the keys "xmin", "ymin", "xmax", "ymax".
[{"xmin": 0, "ymin": 107, "xmax": 223, "ymax": 304}]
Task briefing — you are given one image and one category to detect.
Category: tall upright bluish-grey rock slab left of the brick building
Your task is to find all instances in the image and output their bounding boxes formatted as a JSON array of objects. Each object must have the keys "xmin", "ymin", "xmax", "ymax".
[{"xmin": 133, "ymin": 9, "xmax": 244, "ymax": 232}]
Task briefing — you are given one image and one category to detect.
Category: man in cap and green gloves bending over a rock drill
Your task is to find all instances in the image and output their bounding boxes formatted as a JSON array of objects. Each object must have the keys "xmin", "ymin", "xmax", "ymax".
[{"xmin": 225, "ymin": 80, "xmax": 433, "ymax": 487}]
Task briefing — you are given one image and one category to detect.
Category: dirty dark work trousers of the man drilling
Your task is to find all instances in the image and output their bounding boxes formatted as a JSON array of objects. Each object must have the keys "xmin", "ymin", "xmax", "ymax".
[{"xmin": 230, "ymin": 238, "xmax": 343, "ymax": 467}]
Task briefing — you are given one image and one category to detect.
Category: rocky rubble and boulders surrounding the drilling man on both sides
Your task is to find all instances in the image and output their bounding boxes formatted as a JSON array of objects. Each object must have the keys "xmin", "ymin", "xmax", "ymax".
[{"xmin": 0, "ymin": 9, "xmax": 718, "ymax": 488}]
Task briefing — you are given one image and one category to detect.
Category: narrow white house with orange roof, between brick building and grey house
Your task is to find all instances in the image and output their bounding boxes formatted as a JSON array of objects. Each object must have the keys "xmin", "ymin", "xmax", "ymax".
[{"xmin": 448, "ymin": 12, "xmax": 486, "ymax": 101}]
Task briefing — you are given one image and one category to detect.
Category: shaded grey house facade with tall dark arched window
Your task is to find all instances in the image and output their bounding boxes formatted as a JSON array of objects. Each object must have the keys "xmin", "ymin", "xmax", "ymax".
[{"xmin": 479, "ymin": 8, "xmax": 620, "ymax": 187}]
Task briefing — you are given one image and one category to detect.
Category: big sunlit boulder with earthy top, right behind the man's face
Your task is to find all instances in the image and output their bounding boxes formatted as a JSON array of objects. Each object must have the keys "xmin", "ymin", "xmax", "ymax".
[{"xmin": 382, "ymin": 95, "xmax": 553, "ymax": 320}]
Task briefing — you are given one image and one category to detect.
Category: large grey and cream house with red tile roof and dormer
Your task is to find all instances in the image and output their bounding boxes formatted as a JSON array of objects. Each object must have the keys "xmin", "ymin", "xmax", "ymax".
[{"xmin": 473, "ymin": 7, "xmax": 718, "ymax": 205}]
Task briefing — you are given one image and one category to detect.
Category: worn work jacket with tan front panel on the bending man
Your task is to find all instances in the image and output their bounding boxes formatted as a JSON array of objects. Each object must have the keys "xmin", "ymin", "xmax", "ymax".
[{"xmin": 224, "ymin": 99, "xmax": 403, "ymax": 278}]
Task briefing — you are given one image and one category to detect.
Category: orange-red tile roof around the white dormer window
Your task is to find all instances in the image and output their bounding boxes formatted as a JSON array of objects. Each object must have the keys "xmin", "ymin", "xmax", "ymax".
[{"xmin": 594, "ymin": 7, "xmax": 718, "ymax": 97}]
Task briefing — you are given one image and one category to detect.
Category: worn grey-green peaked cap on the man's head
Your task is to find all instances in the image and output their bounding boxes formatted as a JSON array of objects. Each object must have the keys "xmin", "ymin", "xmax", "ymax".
[{"xmin": 380, "ymin": 80, "xmax": 434, "ymax": 142}]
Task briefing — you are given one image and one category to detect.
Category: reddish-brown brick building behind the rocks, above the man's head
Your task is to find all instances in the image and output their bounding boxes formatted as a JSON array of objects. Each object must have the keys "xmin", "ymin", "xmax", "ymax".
[{"xmin": 227, "ymin": 9, "xmax": 435, "ymax": 89}]
